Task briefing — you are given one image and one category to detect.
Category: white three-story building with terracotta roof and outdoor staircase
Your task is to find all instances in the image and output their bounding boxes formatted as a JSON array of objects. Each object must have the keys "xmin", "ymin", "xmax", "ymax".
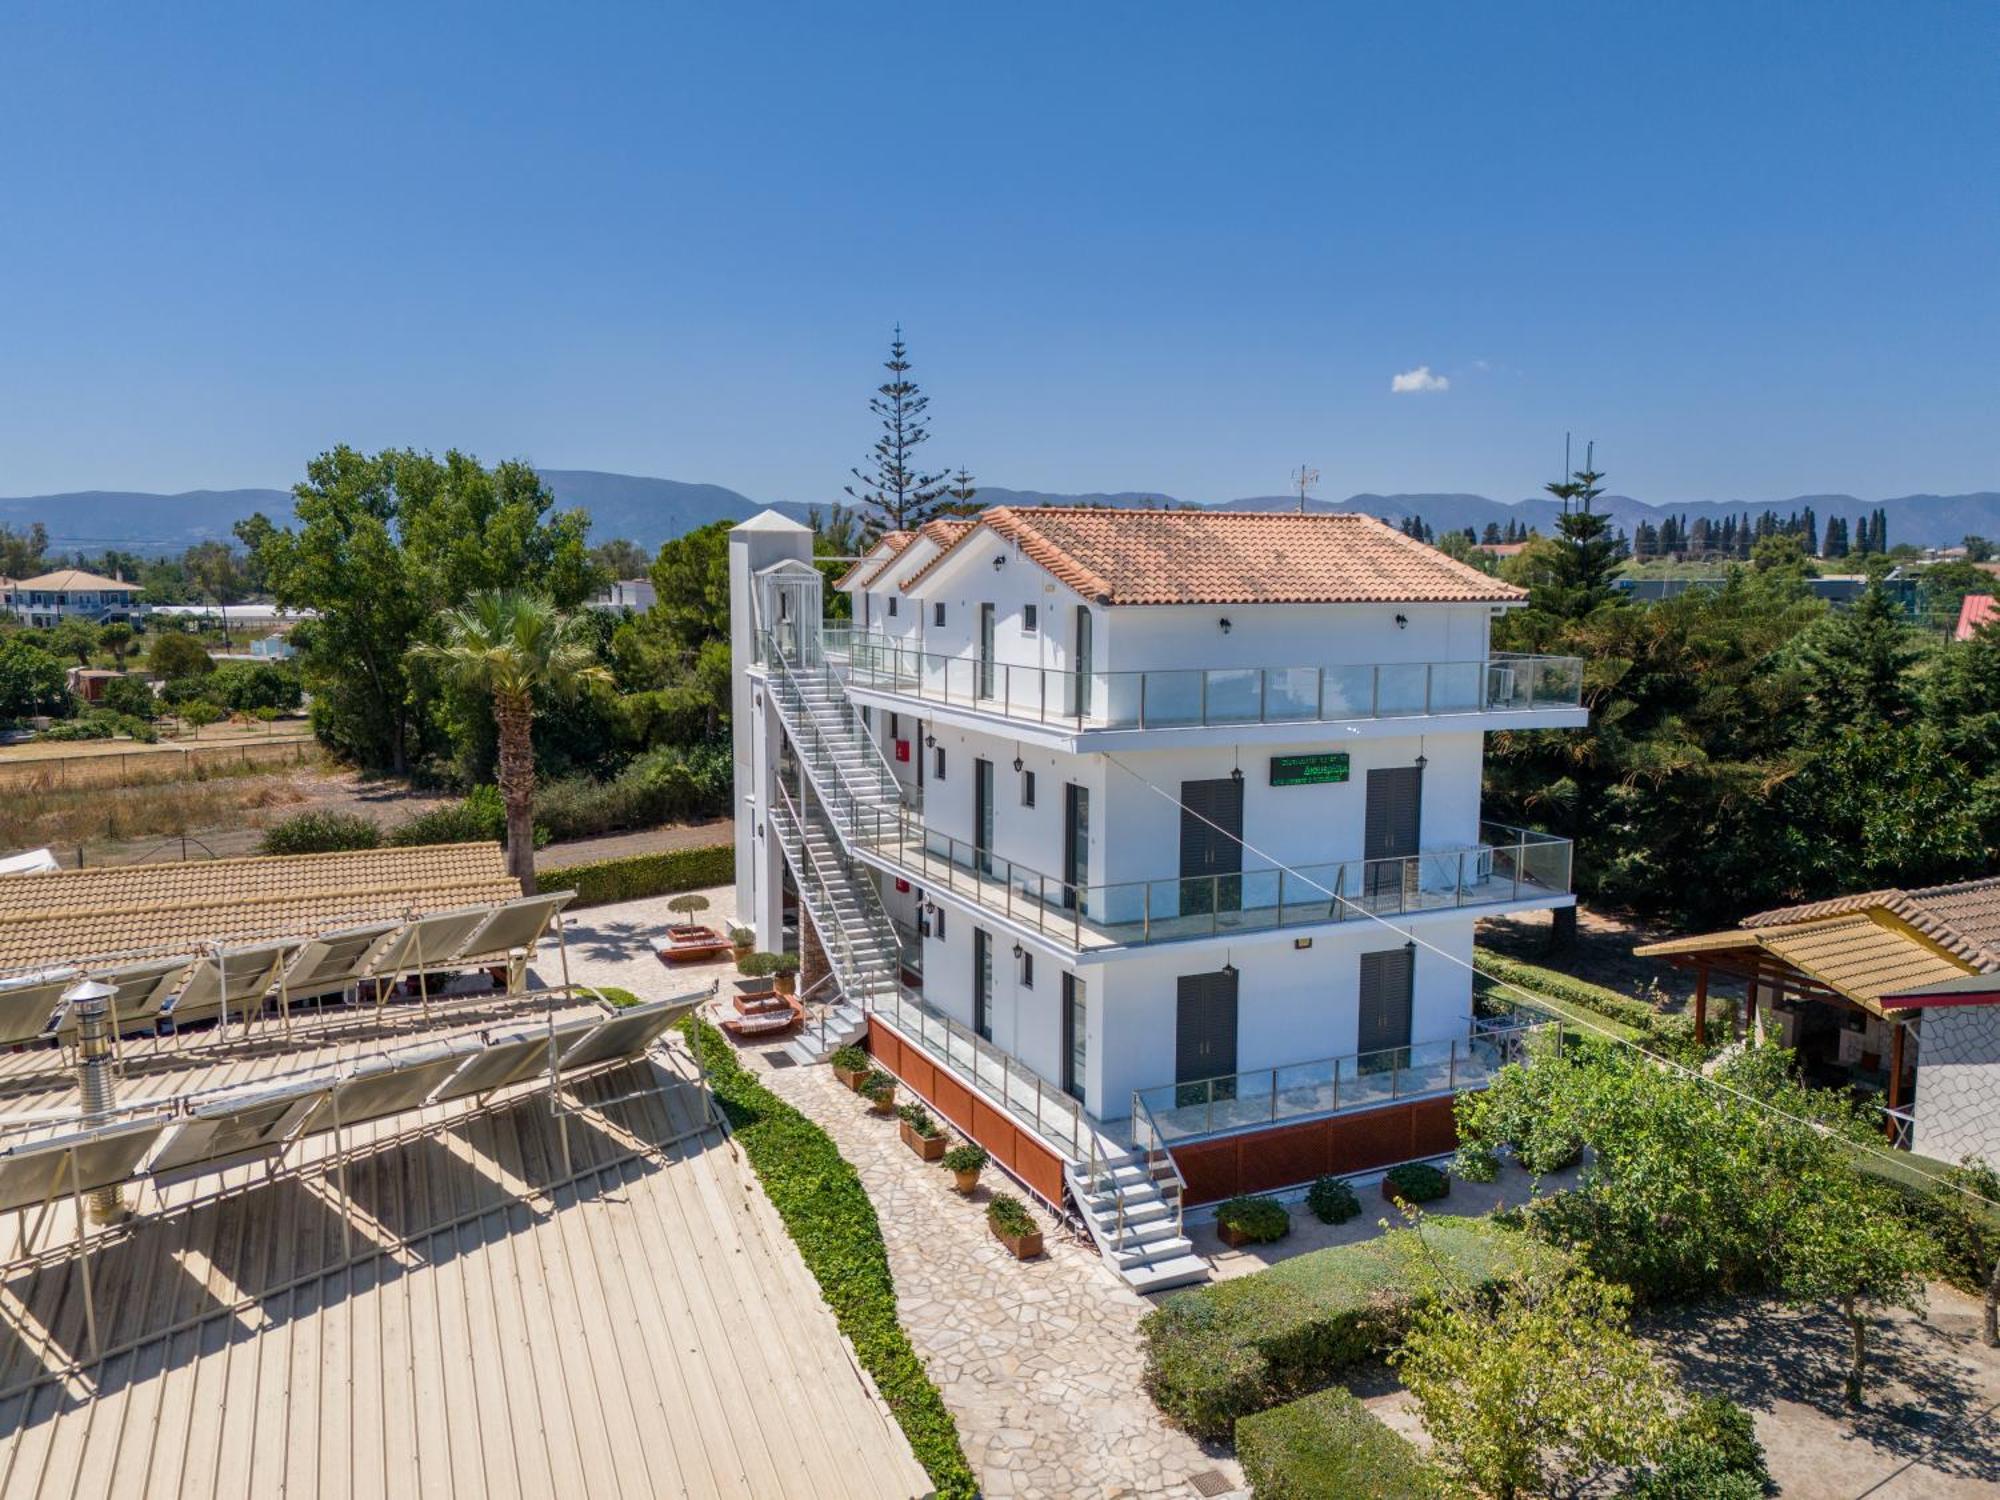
[{"xmin": 730, "ymin": 508, "xmax": 1584, "ymax": 1286}]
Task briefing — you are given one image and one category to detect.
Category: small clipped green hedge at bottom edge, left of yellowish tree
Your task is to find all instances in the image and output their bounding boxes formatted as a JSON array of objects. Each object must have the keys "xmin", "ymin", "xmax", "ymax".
[{"xmin": 1236, "ymin": 1386, "xmax": 1438, "ymax": 1500}]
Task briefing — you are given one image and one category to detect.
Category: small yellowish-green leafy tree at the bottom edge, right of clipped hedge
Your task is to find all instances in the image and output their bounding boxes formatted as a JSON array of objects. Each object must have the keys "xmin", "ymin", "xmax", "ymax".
[{"xmin": 1390, "ymin": 1266, "xmax": 1680, "ymax": 1500}]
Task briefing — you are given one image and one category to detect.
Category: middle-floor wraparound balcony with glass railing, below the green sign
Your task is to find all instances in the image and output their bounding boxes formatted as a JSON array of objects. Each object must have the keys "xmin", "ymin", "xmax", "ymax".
[{"xmin": 850, "ymin": 808, "xmax": 1570, "ymax": 950}]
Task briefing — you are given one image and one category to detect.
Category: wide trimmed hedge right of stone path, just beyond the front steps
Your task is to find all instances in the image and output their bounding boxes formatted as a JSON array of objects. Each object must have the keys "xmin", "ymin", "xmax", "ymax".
[{"xmin": 1142, "ymin": 1218, "xmax": 1562, "ymax": 1440}]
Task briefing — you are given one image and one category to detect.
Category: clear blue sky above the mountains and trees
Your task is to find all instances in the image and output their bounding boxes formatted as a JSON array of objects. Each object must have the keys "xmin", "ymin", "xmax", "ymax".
[{"xmin": 0, "ymin": 0, "xmax": 2000, "ymax": 500}]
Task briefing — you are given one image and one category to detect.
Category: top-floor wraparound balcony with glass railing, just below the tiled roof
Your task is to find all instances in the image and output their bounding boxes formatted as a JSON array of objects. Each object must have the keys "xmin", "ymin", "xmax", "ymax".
[{"xmin": 824, "ymin": 626, "xmax": 1584, "ymax": 730}]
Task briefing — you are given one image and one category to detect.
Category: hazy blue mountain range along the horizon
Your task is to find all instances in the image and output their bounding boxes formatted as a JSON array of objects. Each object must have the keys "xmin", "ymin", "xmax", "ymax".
[{"xmin": 0, "ymin": 468, "xmax": 2000, "ymax": 554}]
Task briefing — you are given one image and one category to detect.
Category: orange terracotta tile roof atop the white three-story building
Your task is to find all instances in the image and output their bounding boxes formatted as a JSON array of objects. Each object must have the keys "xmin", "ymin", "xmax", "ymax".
[{"xmin": 902, "ymin": 506, "xmax": 1528, "ymax": 604}]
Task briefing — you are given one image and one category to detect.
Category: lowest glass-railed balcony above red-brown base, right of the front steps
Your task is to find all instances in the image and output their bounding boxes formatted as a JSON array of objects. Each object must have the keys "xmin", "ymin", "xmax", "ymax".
[{"xmin": 1132, "ymin": 1020, "xmax": 1562, "ymax": 1150}]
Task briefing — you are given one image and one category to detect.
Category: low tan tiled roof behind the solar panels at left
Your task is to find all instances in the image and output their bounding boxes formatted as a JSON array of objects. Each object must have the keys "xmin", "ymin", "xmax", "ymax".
[{"xmin": 0, "ymin": 844, "xmax": 520, "ymax": 974}]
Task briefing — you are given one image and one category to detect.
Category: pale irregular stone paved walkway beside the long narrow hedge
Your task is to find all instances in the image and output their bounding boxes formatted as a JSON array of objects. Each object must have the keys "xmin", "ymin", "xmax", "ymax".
[{"xmin": 744, "ymin": 1052, "xmax": 1242, "ymax": 1500}]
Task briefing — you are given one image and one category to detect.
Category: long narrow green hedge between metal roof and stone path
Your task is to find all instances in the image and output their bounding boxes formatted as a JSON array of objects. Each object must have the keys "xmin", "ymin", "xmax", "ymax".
[{"xmin": 682, "ymin": 1024, "xmax": 980, "ymax": 1500}]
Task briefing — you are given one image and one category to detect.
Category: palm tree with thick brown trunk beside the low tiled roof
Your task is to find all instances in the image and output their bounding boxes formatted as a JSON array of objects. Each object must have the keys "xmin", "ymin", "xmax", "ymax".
[{"xmin": 410, "ymin": 588, "xmax": 612, "ymax": 894}]
